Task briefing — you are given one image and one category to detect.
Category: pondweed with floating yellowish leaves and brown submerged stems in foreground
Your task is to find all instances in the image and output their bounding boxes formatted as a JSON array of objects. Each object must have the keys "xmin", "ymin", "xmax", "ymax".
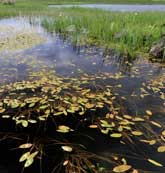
[{"xmin": 0, "ymin": 63, "xmax": 165, "ymax": 173}]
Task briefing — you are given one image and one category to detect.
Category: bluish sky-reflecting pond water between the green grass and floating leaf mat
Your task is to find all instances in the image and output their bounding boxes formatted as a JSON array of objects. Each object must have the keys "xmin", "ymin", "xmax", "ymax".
[{"xmin": 0, "ymin": 16, "xmax": 165, "ymax": 173}]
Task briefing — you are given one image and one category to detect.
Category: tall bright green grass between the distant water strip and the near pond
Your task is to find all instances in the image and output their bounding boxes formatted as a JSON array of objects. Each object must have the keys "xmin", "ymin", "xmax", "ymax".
[{"xmin": 43, "ymin": 8, "xmax": 165, "ymax": 52}]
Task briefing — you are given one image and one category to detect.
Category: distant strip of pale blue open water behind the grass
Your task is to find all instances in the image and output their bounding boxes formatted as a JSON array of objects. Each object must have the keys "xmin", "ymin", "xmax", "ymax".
[{"xmin": 49, "ymin": 4, "xmax": 165, "ymax": 12}]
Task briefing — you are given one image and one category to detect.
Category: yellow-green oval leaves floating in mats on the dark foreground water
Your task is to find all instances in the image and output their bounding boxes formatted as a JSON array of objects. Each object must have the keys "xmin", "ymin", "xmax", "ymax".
[{"xmin": 0, "ymin": 69, "xmax": 165, "ymax": 173}]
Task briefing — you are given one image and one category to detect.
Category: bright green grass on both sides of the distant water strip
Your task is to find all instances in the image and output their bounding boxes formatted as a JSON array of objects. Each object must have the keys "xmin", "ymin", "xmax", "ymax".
[{"xmin": 0, "ymin": 0, "xmax": 165, "ymax": 53}]
